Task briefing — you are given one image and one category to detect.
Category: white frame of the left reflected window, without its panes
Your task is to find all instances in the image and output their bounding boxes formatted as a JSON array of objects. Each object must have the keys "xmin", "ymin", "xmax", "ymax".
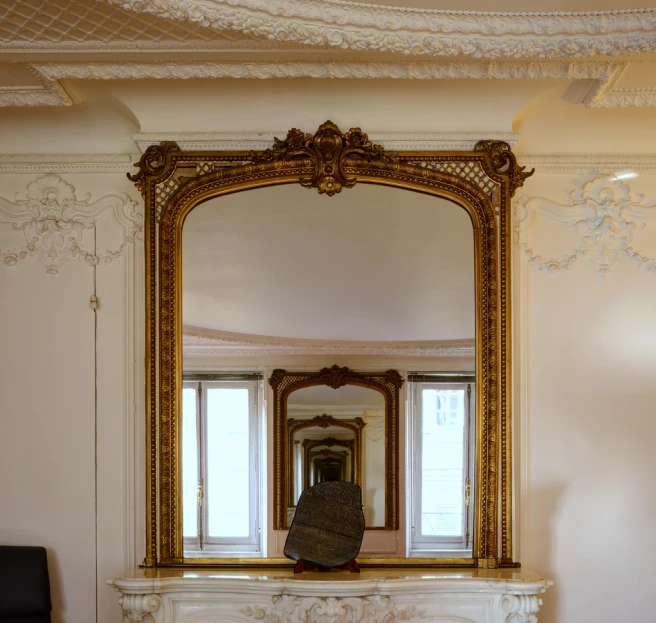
[{"xmin": 182, "ymin": 374, "xmax": 266, "ymax": 558}]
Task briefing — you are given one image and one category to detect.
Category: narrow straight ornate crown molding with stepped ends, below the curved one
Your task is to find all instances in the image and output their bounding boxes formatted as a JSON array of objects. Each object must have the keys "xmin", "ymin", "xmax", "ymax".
[{"xmin": 0, "ymin": 61, "xmax": 656, "ymax": 108}]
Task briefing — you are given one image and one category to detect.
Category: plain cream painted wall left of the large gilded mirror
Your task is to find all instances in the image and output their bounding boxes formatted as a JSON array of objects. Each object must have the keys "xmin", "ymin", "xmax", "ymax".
[{"xmin": 0, "ymin": 174, "xmax": 144, "ymax": 623}]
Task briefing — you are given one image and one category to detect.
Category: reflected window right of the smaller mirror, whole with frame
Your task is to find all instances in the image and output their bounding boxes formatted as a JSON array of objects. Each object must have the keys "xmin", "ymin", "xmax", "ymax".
[{"xmin": 410, "ymin": 377, "xmax": 475, "ymax": 556}]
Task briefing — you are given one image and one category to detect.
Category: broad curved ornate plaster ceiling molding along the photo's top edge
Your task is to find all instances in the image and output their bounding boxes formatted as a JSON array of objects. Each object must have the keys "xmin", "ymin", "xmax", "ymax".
[{"xmin": 105, "ymin": 0, "xmax": 656, "ymax": 58}]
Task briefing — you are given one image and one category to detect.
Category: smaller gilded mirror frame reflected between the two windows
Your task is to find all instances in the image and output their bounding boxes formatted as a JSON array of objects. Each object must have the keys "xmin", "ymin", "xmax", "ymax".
[{"xmin": 269, "ymin": 365, "xmax": 404, "ymax": 530}]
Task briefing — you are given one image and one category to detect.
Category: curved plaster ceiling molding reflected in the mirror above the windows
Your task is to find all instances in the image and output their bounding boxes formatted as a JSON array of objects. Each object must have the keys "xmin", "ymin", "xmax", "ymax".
[{"xmin": 182, "ymin": 325, "xmax": 474, "ymax": 357}]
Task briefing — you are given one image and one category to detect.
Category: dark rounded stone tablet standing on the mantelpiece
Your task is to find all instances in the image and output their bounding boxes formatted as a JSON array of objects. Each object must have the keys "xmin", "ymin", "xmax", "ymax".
[{"xmin": 284, "ymin": 481, "xmax": 364, "ymax": 568}]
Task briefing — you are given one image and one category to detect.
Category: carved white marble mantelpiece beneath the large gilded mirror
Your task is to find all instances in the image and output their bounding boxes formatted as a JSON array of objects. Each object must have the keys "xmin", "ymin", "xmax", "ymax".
[{"xmin": 108, "ymin": 568, "xmax": 553, "ymax": 623}]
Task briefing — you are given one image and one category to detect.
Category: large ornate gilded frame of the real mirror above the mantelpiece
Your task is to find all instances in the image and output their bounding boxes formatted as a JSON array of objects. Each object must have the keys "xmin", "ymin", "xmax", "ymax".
[{"xmin": 128, "ymin": 121, "xmax": 533, "ymax": 568}]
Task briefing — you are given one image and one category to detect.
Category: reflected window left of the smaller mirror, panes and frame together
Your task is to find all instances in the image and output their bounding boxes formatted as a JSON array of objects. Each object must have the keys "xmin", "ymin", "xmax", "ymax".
[{"xmin": 182, "ymin": 377, "xmax": 264, "ymax": 557}]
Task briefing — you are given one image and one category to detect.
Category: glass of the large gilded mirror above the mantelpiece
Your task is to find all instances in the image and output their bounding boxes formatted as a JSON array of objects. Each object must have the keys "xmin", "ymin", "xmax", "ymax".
[{"xmin": 181, "ymin": 183, "xmax": 476, "ymax": 558}]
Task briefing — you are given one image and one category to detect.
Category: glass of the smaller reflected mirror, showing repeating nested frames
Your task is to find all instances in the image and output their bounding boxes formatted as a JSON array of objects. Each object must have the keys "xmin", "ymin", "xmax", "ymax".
[{"xmin": 287, "ymin": 385, "xmax": 385, "ymax": 528}]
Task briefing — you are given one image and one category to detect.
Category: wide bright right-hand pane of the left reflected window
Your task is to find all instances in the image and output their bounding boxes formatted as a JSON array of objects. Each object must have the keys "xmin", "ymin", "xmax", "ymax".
[{"xmin": 206, "ymin": 388, "xmax": 250, "ymax": 537}]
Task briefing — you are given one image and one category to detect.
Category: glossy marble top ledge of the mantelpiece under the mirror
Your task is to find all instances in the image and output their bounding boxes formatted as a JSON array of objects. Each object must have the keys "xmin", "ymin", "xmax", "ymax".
[{"xmin": 107, "ymin": 568, "xmax": 553, "ymax": 597}]
